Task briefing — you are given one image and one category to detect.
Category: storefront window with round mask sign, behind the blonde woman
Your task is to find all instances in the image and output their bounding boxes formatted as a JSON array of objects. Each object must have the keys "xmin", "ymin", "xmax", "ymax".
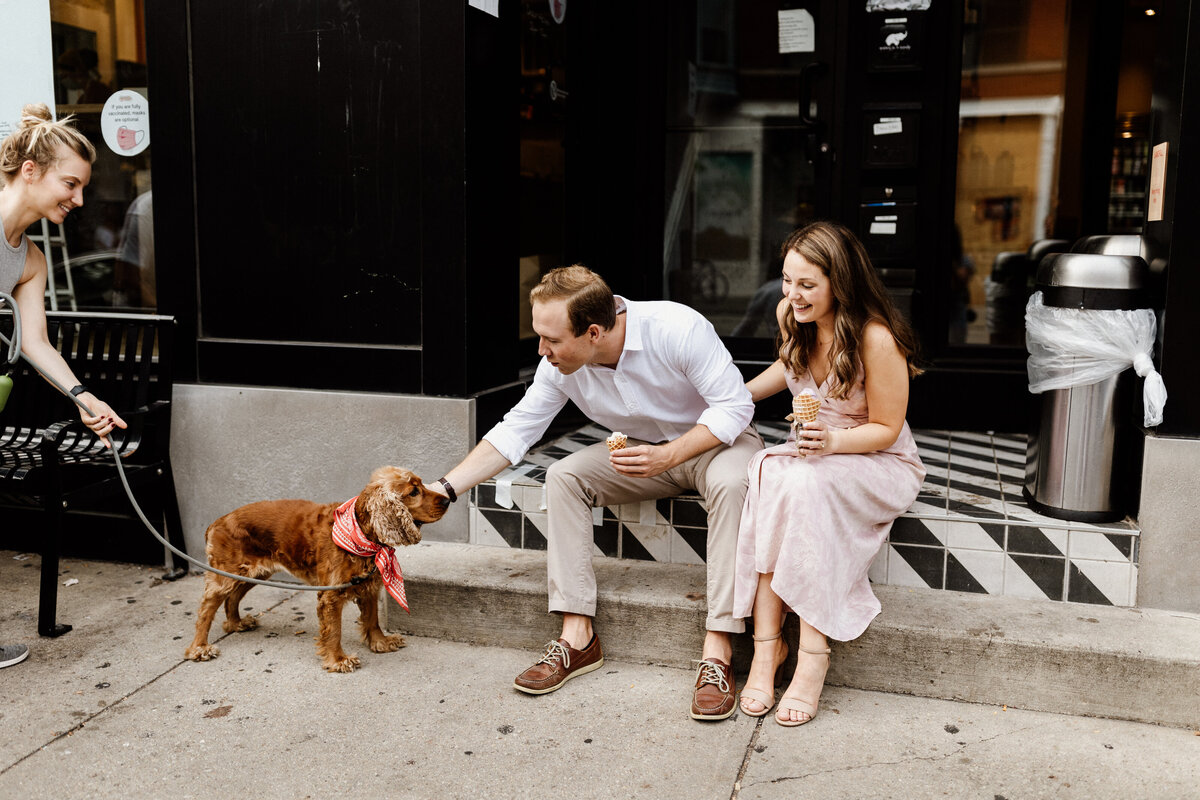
[{"xmin": 42, "ymin": 0, "xmax": 157, "ymax": 311}]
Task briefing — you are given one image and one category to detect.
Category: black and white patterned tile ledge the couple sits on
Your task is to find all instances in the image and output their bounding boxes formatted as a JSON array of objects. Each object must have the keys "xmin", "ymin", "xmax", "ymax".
[{"xmin": 470, "ymin": 422, "xmax": 1139, "ymax": 606}]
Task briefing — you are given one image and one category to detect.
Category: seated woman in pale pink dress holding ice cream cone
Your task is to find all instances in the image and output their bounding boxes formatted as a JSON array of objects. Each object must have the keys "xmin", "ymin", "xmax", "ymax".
[{"xmin": 733, "ymin": 222, "xmax": 925, "ymax": 726}]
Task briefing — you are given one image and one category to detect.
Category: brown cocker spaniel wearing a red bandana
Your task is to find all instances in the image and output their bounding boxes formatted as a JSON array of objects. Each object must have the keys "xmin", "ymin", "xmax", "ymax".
[{"xmin": 184, "ymin": 467, "xmax": 450, "ymax": 672}]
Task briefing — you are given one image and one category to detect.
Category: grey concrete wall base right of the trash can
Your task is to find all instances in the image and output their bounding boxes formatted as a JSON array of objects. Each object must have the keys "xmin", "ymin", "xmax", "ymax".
[{"xmin": 1138, "ymin": 437, "xmax": 1200, "ymax": 613}]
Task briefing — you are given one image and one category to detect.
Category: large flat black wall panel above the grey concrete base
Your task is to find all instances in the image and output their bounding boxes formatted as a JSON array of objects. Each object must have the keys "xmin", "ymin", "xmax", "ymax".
[{"xmin": 191, "ymin": 0, "xmax": 421, "ymax": 344}]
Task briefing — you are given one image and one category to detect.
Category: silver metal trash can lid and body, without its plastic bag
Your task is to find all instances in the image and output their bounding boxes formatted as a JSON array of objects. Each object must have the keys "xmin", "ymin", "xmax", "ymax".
[{"xmin": 1024, "ymin": 252, "xmax": 1150, "ymax": 522}]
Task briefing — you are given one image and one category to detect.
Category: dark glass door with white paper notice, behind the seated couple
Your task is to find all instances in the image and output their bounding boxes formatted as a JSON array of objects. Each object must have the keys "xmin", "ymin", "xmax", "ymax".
[{"xmin": 662, "ymin": 0, "xmax": 838, "ymax": 349}]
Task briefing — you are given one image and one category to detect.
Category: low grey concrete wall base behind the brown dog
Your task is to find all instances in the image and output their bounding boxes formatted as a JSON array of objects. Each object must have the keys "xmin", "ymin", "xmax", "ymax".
[{"xmin": 170, "ymin": 384, "xmax": 475, "ymax": 558}]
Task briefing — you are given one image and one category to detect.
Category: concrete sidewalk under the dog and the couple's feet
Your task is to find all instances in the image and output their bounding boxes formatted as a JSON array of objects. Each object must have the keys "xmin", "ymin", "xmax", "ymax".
[{"xmin": 0, "ymin": 552, "xmax": 1200, "ymax": 800}]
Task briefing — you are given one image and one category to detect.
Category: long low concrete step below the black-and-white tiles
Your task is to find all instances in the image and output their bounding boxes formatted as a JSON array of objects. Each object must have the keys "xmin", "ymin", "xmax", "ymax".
[{"xmin": 384, "ymin": 542, "xmax": 1200, "ymax": 728}]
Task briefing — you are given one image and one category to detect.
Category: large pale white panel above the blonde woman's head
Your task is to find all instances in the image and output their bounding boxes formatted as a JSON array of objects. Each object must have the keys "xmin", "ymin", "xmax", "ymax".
[{"xmin": 0, "ymin": 0, "xmax": 55, "ymax": 139}]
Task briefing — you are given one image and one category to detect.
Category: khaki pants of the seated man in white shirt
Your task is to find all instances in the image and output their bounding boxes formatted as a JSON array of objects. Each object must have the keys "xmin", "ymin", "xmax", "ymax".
[{"xmin": 546, "ymin": 427, "xmax": 763, "ymax": 633}]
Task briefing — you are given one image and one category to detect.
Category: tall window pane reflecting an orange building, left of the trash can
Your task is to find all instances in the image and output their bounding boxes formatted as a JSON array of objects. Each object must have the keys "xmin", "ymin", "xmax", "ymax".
[{"xmin": 947, "ymin": 0, "xmax": 1067, "ymax": 347}]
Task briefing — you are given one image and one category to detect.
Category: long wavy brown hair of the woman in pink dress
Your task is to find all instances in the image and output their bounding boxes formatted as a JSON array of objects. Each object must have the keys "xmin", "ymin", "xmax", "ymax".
[{"xmin": 776, "ymin": 222, "xmax": 922, "ymax": 398}]
